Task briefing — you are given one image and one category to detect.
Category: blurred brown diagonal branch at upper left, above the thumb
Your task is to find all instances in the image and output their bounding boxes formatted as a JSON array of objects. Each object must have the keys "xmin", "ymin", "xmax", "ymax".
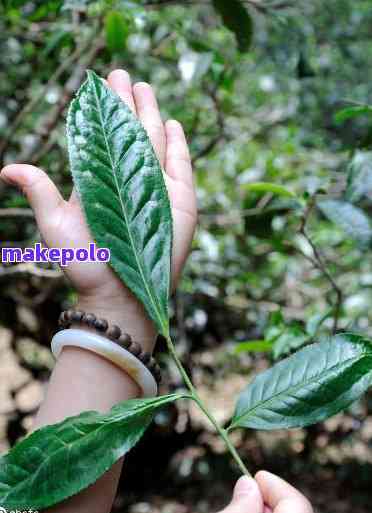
[{"xmin": 20, "ymin": 37, "xmax": 104, "ymax": 164}]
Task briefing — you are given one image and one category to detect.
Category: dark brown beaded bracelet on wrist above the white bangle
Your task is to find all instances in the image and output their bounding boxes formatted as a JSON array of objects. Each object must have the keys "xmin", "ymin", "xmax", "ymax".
[{"xmin": 58, "ymin": 310, "xmax": 161, "ymax": 384}]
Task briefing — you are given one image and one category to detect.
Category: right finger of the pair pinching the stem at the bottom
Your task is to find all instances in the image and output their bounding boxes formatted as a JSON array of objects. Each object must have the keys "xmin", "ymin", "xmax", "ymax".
[{"xmin": 255, "ymin": 471, "xmax": 313, "ymax": 513}]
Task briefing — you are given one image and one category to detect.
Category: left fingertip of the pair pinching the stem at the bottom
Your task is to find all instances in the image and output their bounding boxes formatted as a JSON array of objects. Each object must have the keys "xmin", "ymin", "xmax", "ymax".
[{"xmin": 220, "ymin": 476, "xmax": 263, "ymax": 513}]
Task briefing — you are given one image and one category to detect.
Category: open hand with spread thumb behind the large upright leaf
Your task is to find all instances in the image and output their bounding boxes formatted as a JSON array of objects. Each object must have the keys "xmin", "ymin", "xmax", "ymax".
[{"xmin": 0, "ymin": 70, "xmax": 197, "ymax": 350}]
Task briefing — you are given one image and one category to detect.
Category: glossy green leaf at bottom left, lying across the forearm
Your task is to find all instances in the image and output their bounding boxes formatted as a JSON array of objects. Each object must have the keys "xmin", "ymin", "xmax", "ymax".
[{"xmin": 0, "ymin": 394, "xmax": 182, "ymax": 510}]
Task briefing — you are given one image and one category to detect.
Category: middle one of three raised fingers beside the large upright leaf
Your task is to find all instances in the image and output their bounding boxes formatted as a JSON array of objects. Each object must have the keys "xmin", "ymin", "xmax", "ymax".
[{"xmin": 133, "ymin": 82, "xmax": 166, "ymax": 167}]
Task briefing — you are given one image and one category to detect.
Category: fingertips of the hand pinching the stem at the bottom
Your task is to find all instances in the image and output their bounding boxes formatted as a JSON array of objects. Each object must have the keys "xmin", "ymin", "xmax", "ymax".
[{"xmin": 219, "ymin": 471, "xmax": 313, "ymax": 513}]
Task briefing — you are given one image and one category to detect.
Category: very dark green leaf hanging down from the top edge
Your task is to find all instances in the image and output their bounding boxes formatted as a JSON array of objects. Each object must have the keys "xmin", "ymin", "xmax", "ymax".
[{"xmin": 213, "ymin": 0, "xmax": 253, "ymax": 52}]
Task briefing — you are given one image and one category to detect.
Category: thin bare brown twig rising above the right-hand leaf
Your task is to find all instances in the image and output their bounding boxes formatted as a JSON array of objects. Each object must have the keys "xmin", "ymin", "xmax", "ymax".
[{"xmin": 299, "ymin": 198, "xmax": 343, "ymax": 333}]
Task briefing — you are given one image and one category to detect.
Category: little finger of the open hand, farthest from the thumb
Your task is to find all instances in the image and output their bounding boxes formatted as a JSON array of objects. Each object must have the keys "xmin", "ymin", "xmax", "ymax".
[{"xmin": 165, "ymin": 120, "xmax": 194, "ymax": 190}]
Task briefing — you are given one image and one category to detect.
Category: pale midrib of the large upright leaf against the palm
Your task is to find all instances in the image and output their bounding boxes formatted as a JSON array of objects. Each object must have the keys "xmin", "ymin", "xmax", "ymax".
[{"xmin": 90, "ymin": 78, "xmax": 166, "ymax": 335}]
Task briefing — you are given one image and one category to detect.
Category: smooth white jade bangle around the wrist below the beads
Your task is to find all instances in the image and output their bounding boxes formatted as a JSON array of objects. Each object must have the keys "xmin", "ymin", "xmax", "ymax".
[{"xmin": 51, "ymin": 329, "xmax": 158, "ymax": 397}]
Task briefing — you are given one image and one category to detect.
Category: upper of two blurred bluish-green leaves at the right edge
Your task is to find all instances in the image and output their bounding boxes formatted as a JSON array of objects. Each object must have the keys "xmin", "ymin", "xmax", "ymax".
[{"xmin": 345, "ymin": 151, "xmax": 372, "ymax": 203}]
